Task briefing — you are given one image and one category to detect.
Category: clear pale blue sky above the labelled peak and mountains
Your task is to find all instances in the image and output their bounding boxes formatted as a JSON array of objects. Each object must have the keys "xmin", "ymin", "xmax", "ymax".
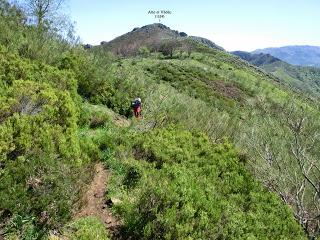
[{"xmin": 67, "ymin": 0, "xmax": 320, "ymax": 51}]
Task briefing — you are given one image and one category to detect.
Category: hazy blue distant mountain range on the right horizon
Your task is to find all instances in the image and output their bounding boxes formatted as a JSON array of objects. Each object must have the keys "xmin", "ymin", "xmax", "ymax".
[{"xmin": 252, "ymin": 46, "xmax": 320, "ymax": 67}]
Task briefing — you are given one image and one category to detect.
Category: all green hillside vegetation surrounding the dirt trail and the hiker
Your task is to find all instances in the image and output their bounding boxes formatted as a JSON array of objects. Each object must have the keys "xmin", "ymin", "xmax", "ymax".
[{"xmin": 0, "ymin": 0, "xmax": 320, "ymax": 239}]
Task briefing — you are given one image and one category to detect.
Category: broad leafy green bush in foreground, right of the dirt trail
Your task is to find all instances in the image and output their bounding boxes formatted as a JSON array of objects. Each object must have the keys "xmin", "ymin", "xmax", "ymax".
[{"xmin": 113, "ymin": 127, "xmax": 304, "ymax": 239}]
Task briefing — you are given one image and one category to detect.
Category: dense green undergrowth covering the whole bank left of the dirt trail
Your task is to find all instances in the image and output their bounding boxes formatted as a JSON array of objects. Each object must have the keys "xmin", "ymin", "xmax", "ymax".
[{"xmin": 0, "ymin": 4, "xmax": 99, "ymax": 236}]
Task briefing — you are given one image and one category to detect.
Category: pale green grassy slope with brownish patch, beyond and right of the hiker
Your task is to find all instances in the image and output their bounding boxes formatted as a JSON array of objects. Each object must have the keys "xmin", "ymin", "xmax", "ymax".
[{"xmin": 92, "ymin": 48, "xmax": 319, "ymax": 237}]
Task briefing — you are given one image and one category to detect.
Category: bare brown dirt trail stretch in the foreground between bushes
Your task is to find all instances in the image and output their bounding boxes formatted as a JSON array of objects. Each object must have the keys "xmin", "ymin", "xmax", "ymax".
[{"xmin": 75, "ymin": 163, "xmax": 121, "ymax": 235}]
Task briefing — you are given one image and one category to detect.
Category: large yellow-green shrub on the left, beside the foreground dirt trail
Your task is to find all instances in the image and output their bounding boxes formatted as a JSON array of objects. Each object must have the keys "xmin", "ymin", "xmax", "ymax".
[{"xmin": 0, "ymin": 81, "xmax": 92, "ymax": 232}]
